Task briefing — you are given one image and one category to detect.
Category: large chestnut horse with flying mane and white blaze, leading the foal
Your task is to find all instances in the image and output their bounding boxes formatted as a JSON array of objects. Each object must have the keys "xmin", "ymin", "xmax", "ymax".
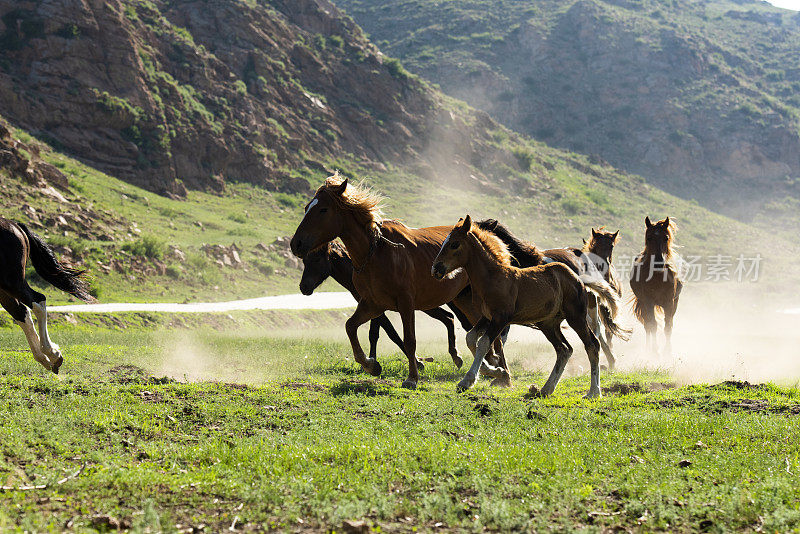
[{"xmin": 291, "ymin": 174, "xmax": 467, "ymax": 389}]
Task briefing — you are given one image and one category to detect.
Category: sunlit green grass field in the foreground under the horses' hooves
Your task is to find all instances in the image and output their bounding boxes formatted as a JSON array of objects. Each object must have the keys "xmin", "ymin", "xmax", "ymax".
[{"xmin": 0, "ymin": 312, "xmax": 800, "ymax": 532}]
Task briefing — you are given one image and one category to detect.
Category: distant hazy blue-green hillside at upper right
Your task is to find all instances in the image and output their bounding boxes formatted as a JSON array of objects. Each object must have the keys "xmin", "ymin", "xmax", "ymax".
[{"xmin": 338, "ymin": 0, "xmax": 800, "ymax": 222}]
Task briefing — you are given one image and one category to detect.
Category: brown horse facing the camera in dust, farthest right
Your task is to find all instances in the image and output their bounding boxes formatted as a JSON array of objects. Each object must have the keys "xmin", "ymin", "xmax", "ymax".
[{"xmin": 631, "ymin": 217, "xmax": 683, "ymax": 355}]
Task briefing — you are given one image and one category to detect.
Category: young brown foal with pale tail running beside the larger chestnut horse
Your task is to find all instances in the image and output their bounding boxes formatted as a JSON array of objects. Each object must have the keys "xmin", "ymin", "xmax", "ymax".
[{"xmin": 431, "ymin": 215, "xmax": 618, "ymax": 397}]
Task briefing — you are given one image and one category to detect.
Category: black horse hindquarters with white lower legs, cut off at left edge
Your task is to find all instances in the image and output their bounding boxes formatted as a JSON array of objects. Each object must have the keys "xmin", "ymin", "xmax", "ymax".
[{"xmin": 0, "ymin": 217, "xmax": 94, "ymax": 374}]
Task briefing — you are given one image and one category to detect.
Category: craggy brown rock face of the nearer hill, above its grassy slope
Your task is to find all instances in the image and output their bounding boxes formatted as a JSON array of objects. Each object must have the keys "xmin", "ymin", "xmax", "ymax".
[{"xmin": 0, "ymin": 0, "xmax": 532, "ymax": 197}]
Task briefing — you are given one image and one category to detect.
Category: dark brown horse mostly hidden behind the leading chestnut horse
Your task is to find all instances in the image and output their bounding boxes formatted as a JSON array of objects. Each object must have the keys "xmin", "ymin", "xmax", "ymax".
[{"xmin": 300, "ymin": 241, "xmax": 463, "ymax": 369}]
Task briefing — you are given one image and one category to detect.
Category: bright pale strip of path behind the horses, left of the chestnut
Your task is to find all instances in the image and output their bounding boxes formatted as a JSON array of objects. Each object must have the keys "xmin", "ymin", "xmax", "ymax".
[{"xmin": 48, "ymin": 291, "xmax": 356, "ymax": 313}]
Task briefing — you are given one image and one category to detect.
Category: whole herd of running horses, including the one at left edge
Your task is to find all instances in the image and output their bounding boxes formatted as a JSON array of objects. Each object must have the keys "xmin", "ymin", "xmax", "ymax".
[{"xmin": 0, "ymin": 173, "xmax": 682, "ymax": 397}]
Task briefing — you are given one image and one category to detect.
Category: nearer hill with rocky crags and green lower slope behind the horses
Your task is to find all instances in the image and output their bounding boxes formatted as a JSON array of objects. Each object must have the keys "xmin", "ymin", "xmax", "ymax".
[{"xmin": 0, "ymin": 0, "xmax": 800, "ymax": 304}]
